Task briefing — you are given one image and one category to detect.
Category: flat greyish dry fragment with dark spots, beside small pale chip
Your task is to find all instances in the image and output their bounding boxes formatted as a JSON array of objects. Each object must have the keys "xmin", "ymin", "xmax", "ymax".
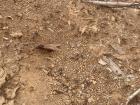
[{"xmin": 103, "ymin": 56, "xmax": 126, "ymax": 78}]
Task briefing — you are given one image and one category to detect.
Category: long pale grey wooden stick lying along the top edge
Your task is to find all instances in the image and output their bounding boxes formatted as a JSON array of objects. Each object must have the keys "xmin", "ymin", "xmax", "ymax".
[{"xmin": 87, "ymin": 0, "xmax": 140, "ymax": 8}]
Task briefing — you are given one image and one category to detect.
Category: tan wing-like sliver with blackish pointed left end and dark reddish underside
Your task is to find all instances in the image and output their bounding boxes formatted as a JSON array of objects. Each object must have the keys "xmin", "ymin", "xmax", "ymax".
[{"xmin": 36, "ymin": 44, "xmax": 61, "ymax": 51}]
